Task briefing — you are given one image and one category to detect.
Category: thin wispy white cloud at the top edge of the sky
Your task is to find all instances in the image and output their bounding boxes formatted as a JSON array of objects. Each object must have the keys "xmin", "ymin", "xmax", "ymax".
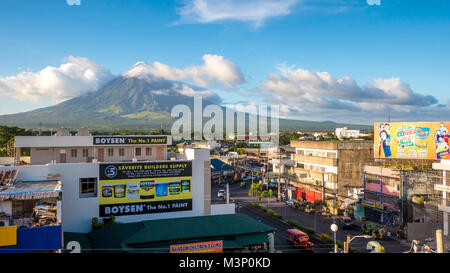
[{"xmin": 178, "ymin": 0, "xmax": 300, "ymax": 27}]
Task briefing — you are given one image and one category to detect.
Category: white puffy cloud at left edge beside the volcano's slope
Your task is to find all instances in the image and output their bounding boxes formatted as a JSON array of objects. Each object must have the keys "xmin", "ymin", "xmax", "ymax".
[{"xmin": 0, "ymin": 56, "xmax": 113, "ymax": 101}]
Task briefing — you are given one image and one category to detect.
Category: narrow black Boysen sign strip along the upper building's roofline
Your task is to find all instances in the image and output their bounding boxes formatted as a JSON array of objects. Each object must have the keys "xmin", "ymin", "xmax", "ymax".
[{"xmin": 93, "ymin": 136, "xmax": 167, "ymax": 145}]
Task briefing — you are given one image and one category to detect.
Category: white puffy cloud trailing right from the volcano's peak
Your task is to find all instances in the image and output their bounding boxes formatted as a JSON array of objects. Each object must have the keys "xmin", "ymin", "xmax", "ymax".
[{"xmin": 123, "ymin": 54, "xmax": 245, "ymax": 89}]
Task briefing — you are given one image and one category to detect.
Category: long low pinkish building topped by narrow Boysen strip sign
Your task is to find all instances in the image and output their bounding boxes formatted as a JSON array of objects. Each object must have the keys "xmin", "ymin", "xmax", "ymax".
[{"xmin": 15, "ymin": 128, "xmax": 172, "ymax": 165}]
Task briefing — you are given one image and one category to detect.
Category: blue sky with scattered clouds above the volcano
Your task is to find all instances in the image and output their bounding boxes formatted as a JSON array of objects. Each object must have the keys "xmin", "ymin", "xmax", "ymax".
[{"xmin": 0, "ymin": 0, "xmax": 450, "ymax": 123}]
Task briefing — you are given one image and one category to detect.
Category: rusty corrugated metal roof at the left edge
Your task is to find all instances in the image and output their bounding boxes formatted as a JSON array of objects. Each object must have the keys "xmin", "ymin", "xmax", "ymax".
[{"xmin": 0, "ymin": 181, "xmax": 61, "ymax": 201}]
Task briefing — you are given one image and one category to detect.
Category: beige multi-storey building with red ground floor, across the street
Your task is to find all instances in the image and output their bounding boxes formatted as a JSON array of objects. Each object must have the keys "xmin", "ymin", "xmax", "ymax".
[{"xmin": 290, "ymin": 140, "xmax": 374, "ymax": 202}]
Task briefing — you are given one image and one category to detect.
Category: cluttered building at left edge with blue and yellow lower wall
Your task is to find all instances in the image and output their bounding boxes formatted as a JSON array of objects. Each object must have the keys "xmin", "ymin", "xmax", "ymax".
[{"xmin": 0, "ymin": 170, "xmax": 62, "ymax": 253}]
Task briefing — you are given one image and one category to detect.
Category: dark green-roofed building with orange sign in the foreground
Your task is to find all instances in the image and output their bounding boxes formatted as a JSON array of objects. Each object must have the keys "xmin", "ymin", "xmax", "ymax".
[{"xmin": 65, "ymin": 214, "xmax": 276, "ymax": 253}]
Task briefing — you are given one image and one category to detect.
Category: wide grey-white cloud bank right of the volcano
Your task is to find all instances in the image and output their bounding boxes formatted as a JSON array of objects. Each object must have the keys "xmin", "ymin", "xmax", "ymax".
[{"xmin": 258, "ymin": 65, "xmax": 442, "ymax": 123}]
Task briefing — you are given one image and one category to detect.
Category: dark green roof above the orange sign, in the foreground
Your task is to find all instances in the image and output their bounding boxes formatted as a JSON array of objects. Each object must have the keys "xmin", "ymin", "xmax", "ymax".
[{"xmin": 72, "ymin": 214, "xmax": 276, "ymax": 252}]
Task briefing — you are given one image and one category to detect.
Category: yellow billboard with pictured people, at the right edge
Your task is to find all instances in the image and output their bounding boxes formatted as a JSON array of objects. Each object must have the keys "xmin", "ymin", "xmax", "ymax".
[{"xmin": 374, "ymin": 122, "xmax": 450, "ymax": 159}]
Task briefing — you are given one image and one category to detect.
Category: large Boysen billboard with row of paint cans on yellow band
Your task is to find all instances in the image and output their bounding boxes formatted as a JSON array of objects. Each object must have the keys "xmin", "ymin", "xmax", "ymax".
[{"xmin": 99, "ymin": 161, "xmax": 192, "ymax": 217}]
